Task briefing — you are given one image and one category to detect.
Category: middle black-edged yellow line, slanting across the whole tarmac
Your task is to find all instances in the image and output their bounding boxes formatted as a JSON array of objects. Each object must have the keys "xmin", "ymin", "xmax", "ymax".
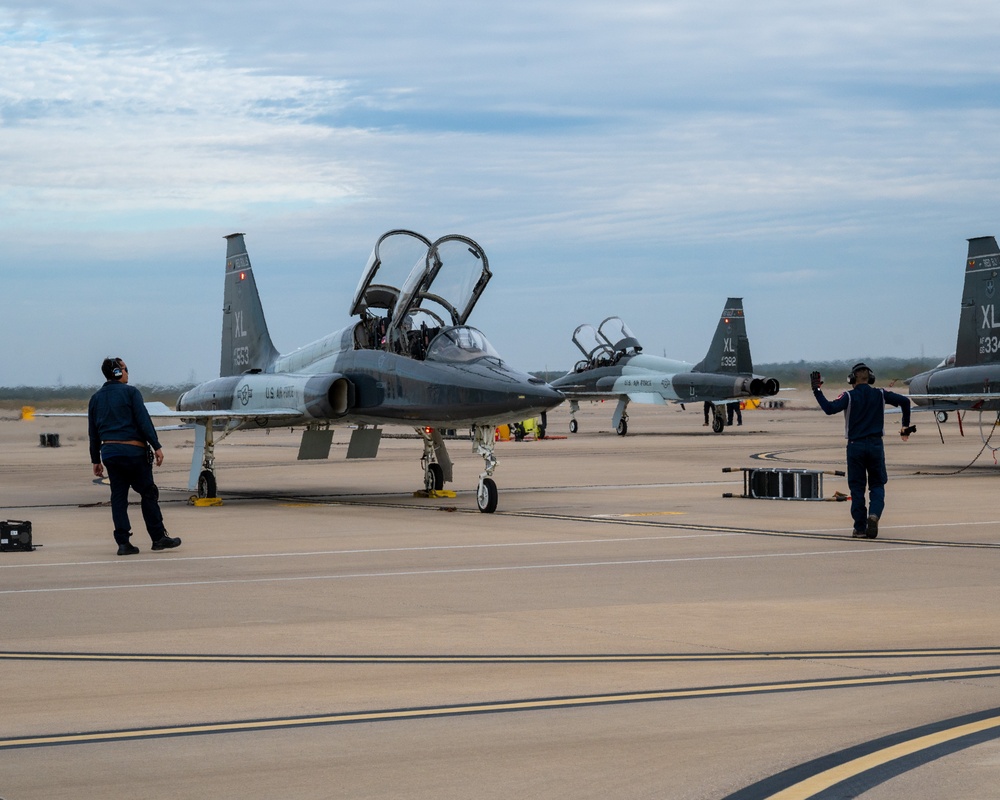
[{"xmin": 0, "ymin": 667, "xmax": 1000, "ymax": 750}]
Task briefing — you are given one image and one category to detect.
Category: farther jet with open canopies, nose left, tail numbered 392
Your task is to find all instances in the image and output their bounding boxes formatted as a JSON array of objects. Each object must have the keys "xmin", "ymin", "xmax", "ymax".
[{"xmin": 552, "ymin": 297, "xmax": 780, "ymax": 436}]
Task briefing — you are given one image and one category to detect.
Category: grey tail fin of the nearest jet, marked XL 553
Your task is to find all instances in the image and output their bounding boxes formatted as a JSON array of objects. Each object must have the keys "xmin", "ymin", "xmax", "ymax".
[{"xmin": 219, "ymin": 233, "xmax": 279, "ymax": 378}]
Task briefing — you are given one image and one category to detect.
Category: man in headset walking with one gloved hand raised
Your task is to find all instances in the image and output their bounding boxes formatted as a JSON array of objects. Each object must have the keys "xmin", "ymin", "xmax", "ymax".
[{"xmin": 809, "ymin": 361, "xmax": 916, "ymax": 539}]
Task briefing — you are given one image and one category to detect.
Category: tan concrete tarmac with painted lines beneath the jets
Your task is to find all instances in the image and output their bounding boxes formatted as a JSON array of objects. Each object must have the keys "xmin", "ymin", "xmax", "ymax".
[{"xmin": 0, "ymin": 400, "xmax": 1000, "ymax": 800}]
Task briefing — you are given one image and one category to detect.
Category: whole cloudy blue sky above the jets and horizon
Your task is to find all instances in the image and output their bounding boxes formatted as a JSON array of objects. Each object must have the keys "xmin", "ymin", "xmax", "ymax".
[{"xmin": 0, "ymin": 0, "xmax": 1000, "ymax": 386}]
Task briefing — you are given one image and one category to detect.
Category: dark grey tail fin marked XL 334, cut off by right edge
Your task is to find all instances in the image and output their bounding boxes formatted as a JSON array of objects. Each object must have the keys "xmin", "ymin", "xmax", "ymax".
[{"xmin": 955, "ymin": 236, "xmax": 1000, "ymax": 367}]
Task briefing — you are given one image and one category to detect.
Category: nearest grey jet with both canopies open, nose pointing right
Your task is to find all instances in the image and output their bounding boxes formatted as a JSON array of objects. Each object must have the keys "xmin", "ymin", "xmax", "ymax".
[{"xmin": 156, "ymin": 230, "xmax": 563, "ymax": 513}]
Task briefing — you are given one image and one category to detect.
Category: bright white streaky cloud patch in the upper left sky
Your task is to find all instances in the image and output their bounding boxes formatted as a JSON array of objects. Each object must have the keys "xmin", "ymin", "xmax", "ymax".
[{"xmin": 0, "ymin": 34, "xmax": 363, "ymax": 220}]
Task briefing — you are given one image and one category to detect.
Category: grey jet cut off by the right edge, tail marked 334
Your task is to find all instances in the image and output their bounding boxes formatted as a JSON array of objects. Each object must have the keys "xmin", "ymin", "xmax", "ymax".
[{"xmin": 907, "ymin": 236, "xmax": 1000, "ymax": 422}]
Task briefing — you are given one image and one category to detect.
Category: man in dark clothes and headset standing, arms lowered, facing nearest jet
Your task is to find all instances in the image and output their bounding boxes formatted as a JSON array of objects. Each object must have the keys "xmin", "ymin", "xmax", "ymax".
[{"xmin": 87, "ymin": 358, "xmax": 181, "ymax": 556}]
